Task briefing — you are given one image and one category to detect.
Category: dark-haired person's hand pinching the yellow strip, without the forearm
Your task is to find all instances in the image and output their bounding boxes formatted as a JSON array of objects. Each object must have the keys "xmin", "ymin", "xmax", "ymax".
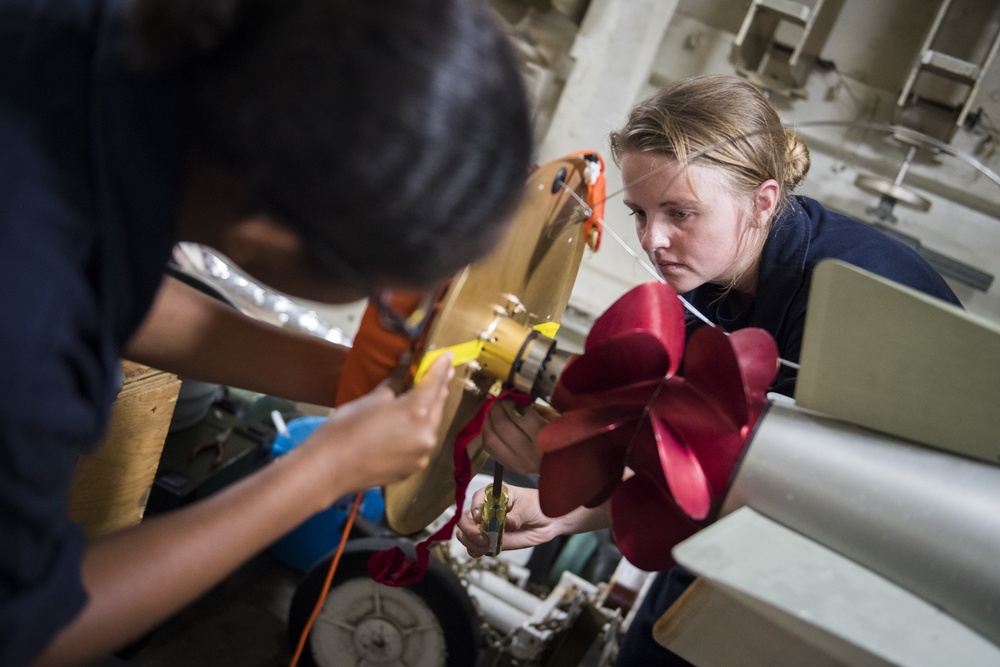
[{"xmin": 304, "ymin": 354, "xmax": 454, "ymax": 502}]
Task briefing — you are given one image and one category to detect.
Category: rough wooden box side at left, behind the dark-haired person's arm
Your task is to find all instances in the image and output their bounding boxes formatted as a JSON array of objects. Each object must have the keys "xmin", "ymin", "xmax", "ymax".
[{"xmin": 69, "ymin": 361, "xmax": 181, "ymax": 540}]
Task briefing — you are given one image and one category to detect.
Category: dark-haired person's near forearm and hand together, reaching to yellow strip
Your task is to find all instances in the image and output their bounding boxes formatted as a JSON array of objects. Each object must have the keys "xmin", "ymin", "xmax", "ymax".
[{"xmin": 31, "ymin": 353, "xmax": 454, "ymax": 665}]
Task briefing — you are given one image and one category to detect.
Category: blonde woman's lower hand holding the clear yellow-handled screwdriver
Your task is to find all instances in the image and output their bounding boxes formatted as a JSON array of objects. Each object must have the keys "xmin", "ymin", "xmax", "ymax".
[{"xmin": 455, "ymin": 486, "xmax": 559, "ymax": 558}]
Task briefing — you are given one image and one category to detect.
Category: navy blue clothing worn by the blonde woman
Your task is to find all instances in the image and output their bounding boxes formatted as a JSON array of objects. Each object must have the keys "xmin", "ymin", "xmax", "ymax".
[{"xmin": 618, "ymin": 196, "xmax": 961, "ymax": 667}]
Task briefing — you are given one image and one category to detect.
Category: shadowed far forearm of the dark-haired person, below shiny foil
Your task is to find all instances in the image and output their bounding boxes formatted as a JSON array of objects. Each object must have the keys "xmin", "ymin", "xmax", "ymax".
[{"xmin": 124, "ymin": 277, "xmax": 347, "ymax": 406}]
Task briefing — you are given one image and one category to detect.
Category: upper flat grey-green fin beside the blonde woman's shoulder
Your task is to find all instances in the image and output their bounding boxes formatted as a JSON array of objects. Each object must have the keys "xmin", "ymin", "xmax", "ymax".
[{"xmin": 795, "ymin": 260, "xmax": 1000, "ymax": 463}]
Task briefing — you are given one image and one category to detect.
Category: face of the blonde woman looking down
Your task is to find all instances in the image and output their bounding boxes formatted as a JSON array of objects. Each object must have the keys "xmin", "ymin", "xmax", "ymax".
[{"xmin": 621, "ymin": 152, "xmax": 752, "ymax": 293}]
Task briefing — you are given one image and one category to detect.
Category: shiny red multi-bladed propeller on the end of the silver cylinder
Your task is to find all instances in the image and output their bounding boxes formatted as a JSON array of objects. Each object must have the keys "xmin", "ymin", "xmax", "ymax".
[{"xmin": 539, "ymin": 283, "xmax": 778, "ymax": 570}]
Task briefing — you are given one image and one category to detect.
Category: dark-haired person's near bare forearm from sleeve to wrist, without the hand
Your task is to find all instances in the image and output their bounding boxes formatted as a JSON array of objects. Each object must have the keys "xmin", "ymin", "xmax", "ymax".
[{"xmin": 30, "ymin": 438, "xmax": 340, "ymax": 665}]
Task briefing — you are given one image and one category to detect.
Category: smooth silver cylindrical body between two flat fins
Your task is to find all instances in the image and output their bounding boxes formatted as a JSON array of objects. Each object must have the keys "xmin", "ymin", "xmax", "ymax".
[{"xmin": 722, "ymin": 404, "xmax": 1000, "ymax": 644}]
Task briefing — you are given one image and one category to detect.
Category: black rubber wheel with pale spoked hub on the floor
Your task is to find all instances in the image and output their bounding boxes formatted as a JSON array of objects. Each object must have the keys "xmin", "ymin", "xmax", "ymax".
[{"xmin": 288, "ymin": 537, "xmax": 482, "ymax": 667}]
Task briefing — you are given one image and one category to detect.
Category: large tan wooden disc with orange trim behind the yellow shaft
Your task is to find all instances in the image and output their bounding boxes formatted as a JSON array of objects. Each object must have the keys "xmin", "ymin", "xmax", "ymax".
[{"xmin": 385, "ymin": 156, "xmax": 588, "ymax": 535}]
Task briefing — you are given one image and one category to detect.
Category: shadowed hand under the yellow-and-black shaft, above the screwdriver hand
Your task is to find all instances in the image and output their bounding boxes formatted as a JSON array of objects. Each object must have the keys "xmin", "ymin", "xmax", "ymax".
[{"xmin": 483, "ymin": 400, "xmax": 558, "ymax": 475}]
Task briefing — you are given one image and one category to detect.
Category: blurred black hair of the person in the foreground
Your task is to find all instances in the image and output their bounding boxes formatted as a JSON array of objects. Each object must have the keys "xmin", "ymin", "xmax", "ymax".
[{"xmin": 133, "ymin": 0, "xmax": 531, "ymax": 284}]
